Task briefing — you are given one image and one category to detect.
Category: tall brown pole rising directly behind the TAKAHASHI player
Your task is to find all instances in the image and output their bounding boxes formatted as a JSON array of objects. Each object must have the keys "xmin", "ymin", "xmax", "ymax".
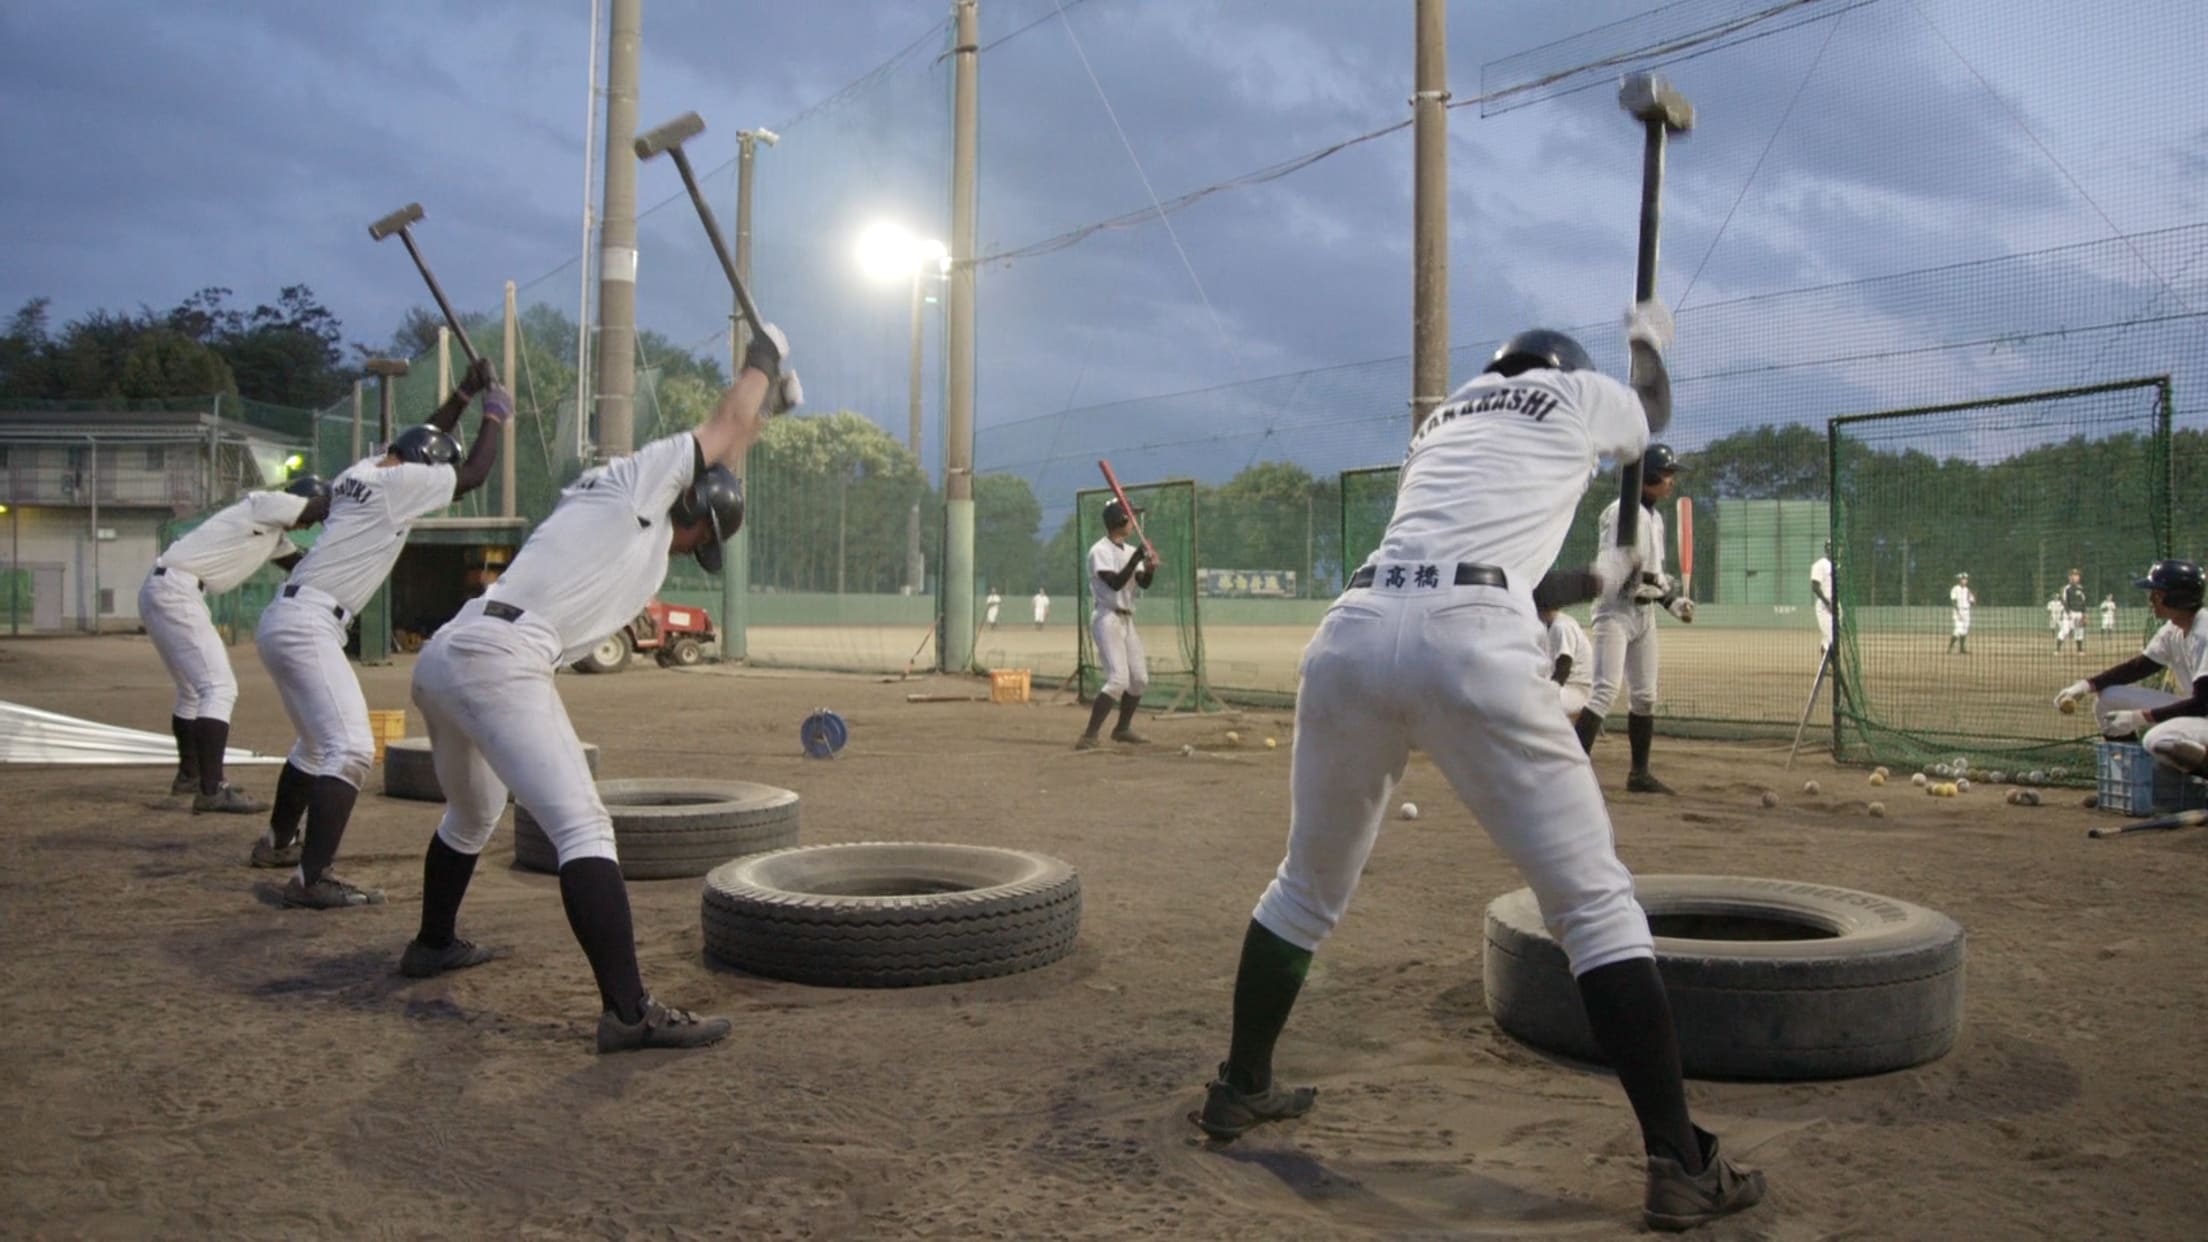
[{"xmin": 1411, "ymin": 0, "xmax": 1448, "ymax": 431}]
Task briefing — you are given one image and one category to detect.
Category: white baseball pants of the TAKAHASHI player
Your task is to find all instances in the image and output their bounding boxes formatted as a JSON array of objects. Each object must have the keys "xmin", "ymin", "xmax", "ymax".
[{"xmin": 1252, "ymin": 586, "xmax": 1656, "ymax": 975}]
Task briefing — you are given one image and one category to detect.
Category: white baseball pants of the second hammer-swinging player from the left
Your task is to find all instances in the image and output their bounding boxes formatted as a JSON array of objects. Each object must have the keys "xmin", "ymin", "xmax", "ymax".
[{"xmin": 254, "ymin": 588, "xmax": 375, "ymax": 789}]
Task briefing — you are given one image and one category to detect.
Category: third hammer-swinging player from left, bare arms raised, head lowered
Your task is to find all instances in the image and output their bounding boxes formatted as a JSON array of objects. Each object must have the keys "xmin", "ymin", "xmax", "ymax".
[{"xmin": 400, "ymin": 327, "xmax": 802, "ymax": 1052}]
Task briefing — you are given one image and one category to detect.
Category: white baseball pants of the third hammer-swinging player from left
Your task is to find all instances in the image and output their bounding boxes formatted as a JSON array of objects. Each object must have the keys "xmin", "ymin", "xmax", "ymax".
[{"xmin": 413, "ymin": 601, "xmax": 618, "ymax": 864}]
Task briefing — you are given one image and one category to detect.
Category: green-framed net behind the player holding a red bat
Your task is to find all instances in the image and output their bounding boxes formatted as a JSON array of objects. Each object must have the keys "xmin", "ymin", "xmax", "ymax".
[{"xmin": 1068, "ymin": 480, "xmax": 1212, "ymax": 712}]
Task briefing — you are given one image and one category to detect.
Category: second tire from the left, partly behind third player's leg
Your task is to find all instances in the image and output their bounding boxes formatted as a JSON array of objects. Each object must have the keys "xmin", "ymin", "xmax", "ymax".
[{"xmin": 514, "ymin": 780, "xmax": 797, "ymax": 880}]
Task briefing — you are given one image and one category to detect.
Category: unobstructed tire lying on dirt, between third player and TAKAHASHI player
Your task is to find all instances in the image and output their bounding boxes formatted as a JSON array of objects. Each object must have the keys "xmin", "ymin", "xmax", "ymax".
[{"xmin": 704, "ymin": 842, "xmax": 1082, "ymax": 988}]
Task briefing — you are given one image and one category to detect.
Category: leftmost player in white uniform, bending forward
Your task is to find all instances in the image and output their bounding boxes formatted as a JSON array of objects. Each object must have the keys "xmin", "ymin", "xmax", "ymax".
[{"xmin": 139, "ymin": 475, "xmax": 329, "ymax": 815}]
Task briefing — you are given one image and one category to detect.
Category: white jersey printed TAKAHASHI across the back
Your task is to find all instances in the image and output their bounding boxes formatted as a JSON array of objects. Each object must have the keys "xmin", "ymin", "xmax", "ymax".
[{"xmin": 1367, "ymin": 371, "xmax": 1663, "ymax": 597}]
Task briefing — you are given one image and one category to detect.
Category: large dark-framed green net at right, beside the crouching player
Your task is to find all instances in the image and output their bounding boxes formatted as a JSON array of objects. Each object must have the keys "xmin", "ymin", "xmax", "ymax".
[{"xmin": 1828, "ymin": 378, "xmax": 2173, "ymax": 782}]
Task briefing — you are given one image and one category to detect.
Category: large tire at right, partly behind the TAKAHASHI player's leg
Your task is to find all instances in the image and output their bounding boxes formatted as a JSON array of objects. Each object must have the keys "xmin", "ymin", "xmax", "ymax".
[{"xmin": 1484, "ymin": 875, "xmax": 1965, "ymax": 1081}]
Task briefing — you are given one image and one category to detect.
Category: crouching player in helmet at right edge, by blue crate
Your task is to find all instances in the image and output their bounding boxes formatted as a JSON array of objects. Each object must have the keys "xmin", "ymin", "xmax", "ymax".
[{"xmin": 2056, "ymin": 561, "xmax": 2208, "ymax": 771}]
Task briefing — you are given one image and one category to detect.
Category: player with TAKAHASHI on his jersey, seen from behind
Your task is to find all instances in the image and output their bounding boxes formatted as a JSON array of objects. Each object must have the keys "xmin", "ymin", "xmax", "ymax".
[{"xmin": 1195, "ymin": 307, "xmax": 1764, "ymax": 1229}]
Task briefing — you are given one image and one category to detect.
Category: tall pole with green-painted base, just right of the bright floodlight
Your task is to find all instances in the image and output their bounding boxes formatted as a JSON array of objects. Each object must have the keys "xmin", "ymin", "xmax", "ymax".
[{"xmin": 936, "ymin": 0, "xmax": 980, "ymax": 672}]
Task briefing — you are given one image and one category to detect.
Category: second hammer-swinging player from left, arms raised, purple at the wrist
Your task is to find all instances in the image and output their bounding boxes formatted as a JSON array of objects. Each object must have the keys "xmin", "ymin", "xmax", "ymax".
[{"xmin": 252, "ymin": 362, "xmax": 514, "ymax": 911}]
